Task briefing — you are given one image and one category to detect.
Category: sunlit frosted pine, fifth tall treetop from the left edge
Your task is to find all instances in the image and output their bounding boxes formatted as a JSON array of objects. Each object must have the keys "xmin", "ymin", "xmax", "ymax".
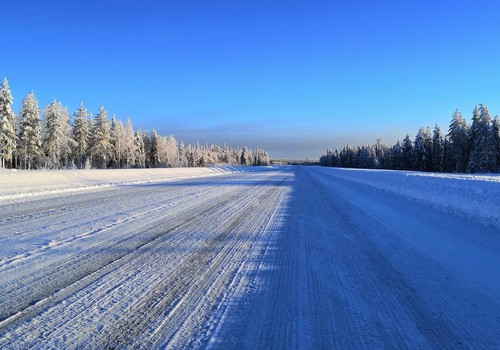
[{"xmin": 90, "ymin": 106, "xmax": 112, "ymax": 169}]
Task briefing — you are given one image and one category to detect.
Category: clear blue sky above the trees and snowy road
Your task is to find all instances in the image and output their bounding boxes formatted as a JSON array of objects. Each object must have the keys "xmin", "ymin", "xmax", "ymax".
[{"xmin": 0, "ymin": 0, "xmax": 500, "ymax": 158}]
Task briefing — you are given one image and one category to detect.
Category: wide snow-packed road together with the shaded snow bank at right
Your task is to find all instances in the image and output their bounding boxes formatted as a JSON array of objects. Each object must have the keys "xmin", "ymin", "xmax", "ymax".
[{"xmin": 0, "ymin": 167, "xmax": 500, "ymax": 349}]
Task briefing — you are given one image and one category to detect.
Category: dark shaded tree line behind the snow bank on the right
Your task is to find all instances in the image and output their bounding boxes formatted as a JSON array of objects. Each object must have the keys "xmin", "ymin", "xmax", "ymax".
[{"xmin": 320, "ymin": 105, "xmax": 500, "ymax": 173}]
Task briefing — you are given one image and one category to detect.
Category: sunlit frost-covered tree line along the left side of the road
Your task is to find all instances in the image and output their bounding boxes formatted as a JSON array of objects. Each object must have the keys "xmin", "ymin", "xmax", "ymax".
[{"xmin": 0, "ymin": 78, "xmax": 269, "ymax": 169}]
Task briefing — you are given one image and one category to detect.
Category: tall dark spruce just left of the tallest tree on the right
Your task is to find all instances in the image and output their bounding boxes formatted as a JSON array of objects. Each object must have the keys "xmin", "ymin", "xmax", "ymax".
[{"xmin": 448, "ymin": 109, "xmax": 469, "ymax": 172}]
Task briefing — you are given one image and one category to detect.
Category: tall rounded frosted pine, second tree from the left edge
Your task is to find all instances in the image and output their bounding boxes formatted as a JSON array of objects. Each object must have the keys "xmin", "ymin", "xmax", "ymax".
[{"xmin": 19, "ymin": 91, "xmax": 42, "ymax": 169}]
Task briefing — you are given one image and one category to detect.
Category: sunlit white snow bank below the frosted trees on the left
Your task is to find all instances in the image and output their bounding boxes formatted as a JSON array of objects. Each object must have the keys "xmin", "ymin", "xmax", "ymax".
[{"xmin": 0, "ymin": 166, "xmax": 246, "ymax": 201}]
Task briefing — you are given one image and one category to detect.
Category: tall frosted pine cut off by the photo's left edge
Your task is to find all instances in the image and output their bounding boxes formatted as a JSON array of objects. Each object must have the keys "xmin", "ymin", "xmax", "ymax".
[{"xmin": 0, "ymin": 78, "xmax": 17, "ymax": 168}]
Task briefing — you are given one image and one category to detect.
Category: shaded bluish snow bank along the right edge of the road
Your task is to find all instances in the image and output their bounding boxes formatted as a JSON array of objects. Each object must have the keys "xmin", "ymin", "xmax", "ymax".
[{"xmin": 320, "ymin": 168, "xmax": 500, "ymax": 228}]
